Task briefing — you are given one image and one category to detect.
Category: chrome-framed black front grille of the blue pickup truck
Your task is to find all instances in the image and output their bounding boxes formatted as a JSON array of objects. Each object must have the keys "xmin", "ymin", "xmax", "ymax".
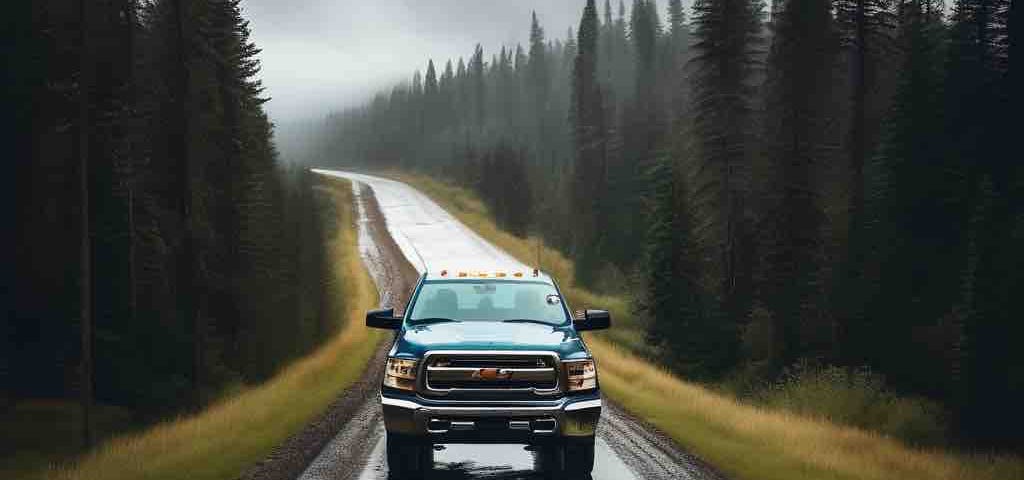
[{"xmin": 425, "ymin": 353, "xmax": 559, "ymax": 395}]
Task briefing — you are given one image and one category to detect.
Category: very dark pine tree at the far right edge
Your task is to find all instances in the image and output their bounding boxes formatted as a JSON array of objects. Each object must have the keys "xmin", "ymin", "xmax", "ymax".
[{"xmin": 947, "ymin": 0, "xmax": 1024, "ymax": 446}]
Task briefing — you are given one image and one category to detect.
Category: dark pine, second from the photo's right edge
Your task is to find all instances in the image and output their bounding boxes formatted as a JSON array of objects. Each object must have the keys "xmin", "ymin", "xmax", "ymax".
[{"xmin": 864, "ymin": 0, "xmax": 969, "ymax": 391}]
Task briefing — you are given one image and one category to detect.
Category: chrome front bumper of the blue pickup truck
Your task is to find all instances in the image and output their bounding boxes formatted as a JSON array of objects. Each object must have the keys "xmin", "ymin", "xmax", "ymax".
[{"xmin": 381, "ymin": 391, "xmax": 601, "ymax": 443}]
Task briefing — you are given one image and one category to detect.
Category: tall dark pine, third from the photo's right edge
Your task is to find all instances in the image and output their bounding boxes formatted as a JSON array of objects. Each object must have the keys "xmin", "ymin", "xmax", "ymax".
[{"xmin": 759, "ymin": 0, "xmax": 838, "ymax": 366}]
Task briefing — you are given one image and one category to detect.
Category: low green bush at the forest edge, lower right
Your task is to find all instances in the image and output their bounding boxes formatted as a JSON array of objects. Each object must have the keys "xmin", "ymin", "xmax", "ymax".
[{"xmin": 755, "ymin": 361, "xmax": 948, "ymax": 446}]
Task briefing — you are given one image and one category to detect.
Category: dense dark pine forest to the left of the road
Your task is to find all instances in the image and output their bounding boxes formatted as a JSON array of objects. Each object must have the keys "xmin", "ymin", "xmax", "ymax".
[{"xmin": 7, "ymin": 0, "xmax": 338, "ymax": 444}]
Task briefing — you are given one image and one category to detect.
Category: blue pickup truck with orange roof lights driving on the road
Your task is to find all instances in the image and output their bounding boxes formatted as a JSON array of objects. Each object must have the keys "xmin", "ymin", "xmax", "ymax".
[{"xmin": 367, "ymin": 270, "xmax": 611, "ymax": 478}]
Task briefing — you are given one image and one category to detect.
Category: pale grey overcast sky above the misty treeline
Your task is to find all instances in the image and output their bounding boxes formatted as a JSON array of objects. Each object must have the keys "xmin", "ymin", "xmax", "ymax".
[{"xmin": 243, "ymin": 0, "xmax": 593, "ymax": 122}]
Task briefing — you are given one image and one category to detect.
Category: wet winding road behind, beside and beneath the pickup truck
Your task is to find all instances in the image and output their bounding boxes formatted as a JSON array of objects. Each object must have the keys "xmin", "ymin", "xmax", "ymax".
[{"xmin": 300, "ymin": 171, "xmax": 718, "ymax": 480}]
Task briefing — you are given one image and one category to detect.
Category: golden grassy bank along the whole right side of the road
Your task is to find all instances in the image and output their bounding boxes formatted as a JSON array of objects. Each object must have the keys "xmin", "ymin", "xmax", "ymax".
[{"xmin": 392, "ymin": 174, "xmax": 1024, "ymax": 480}]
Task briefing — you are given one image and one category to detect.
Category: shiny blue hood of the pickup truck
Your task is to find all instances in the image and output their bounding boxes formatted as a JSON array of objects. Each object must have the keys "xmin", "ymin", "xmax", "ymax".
[{"xmin": 391, "ymin": 321, "xmax": 590, "ymax": 360}]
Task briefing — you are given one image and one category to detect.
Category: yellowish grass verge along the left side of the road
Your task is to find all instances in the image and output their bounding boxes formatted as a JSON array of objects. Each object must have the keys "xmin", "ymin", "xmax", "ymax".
[{"xmin": 37, "ymin": 179, "xmax": 385, "ymax": 480}]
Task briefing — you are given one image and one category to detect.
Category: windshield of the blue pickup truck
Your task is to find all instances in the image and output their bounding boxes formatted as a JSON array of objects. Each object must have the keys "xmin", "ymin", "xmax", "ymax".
[{"xmin": 409, "ymin": 280, "xmax": 568, "ymax": 324}]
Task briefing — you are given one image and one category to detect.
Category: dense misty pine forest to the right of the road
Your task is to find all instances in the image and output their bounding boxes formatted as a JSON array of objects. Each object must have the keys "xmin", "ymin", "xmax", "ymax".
[{"xmin": 302, "ymin": 0, "xmax": 1024, "ymax": 447}]
